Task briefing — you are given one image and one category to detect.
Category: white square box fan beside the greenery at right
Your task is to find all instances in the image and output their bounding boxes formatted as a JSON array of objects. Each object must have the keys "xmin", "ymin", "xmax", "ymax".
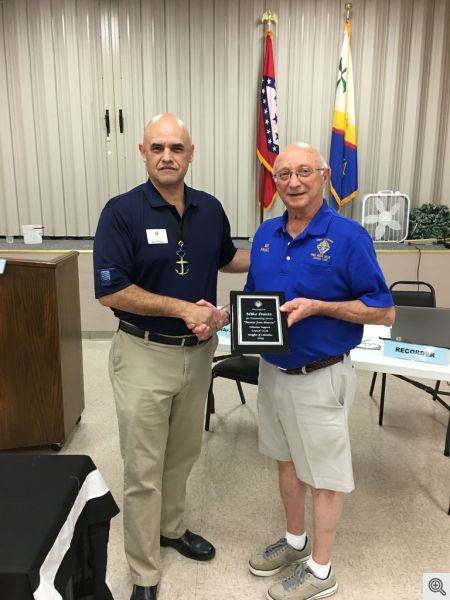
[{"xmin": 361, "ymin": 190, "xmax": 410, "ymax": 242}]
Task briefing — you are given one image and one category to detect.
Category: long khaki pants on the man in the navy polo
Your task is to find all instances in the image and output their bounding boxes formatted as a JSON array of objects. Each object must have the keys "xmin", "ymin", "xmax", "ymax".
[{"xmin": 109, "ymin": 331, "xmax": 217, "ymax": 586}]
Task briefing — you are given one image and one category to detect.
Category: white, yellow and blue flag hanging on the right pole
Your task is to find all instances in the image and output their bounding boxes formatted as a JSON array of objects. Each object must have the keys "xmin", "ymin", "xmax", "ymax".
[{"xmin": 330, "ymin": 19, "xmax": 358, "ymax": 209}]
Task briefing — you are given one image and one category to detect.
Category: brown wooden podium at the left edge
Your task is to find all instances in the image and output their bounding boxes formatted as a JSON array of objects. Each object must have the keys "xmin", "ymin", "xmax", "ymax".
[{"xmin": 0, "ymin": 252, "xmax": 84, "ymax": 450}]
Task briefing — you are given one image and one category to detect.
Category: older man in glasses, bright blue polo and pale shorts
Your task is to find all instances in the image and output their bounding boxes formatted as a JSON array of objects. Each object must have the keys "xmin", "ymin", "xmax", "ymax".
[{"xmin": 246, "ymin": 143, "xmax": 394, "ymax": 600}]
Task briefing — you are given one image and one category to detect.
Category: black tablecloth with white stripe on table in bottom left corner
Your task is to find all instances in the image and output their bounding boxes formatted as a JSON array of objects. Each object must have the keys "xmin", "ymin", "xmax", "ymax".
[{"xmin": 0, "ymin": 455, "xmax": 119, "ymax": 600}]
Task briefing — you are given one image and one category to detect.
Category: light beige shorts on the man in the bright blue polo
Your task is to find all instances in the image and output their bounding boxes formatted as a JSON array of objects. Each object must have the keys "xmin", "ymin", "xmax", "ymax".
[{"xmin": 258, "ymin": 357, "xmax": 356, "ymax": 492}]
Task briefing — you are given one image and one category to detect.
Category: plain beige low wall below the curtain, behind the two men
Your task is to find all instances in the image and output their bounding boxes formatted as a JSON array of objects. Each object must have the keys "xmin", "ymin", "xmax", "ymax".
[{"xmin": 0, "ymin": 248, "xmax": 450, "ymax": 337}]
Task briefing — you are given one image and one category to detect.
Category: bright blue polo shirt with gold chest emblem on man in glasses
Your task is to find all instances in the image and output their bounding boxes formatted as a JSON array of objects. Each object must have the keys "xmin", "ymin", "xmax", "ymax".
[{"xmin": 245, "ymin": 201, "xmax": 394, "ymax": 368}]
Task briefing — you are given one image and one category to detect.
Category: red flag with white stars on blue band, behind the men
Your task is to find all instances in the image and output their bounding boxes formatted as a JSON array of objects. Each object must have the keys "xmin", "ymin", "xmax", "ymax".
[{"xmin": 256, "ymin": 31, "xmax": 280, "ymax": 208}]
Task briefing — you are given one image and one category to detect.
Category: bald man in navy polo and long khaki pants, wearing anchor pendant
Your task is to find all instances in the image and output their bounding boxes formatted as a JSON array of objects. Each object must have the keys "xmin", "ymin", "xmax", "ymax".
[{"xmin": 94, "ymin": 114, "xmax": 249, "ymax": 600}]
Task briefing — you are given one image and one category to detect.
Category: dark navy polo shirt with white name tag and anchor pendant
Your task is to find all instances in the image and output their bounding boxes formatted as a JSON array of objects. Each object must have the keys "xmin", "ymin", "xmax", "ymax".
[{"xmin": 94, "ymin": 181, "xmax": 236, "ymax": 335}]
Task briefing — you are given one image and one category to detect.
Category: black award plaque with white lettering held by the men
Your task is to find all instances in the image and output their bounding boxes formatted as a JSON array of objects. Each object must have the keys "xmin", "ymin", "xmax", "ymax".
[{"xmin": 230, "ymin": 292, "xmax": 289, "ymax": 354}]
